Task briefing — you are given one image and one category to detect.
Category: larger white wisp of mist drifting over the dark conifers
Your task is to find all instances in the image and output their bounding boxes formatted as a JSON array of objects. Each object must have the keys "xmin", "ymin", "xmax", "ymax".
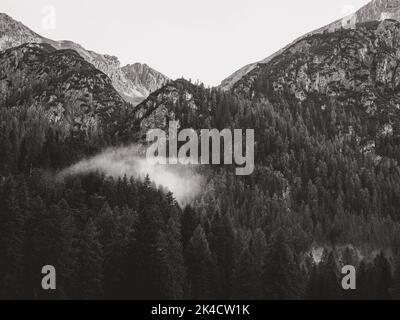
[{"xmin": 58, "ymin": 145, "xmax": 202, "ymax": 205}]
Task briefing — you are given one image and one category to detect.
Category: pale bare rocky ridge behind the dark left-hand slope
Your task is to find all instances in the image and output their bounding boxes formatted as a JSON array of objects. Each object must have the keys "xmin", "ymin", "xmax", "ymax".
[{"xmin": 0, "ymin": 13, "xmax": 168, "ymax": 105}]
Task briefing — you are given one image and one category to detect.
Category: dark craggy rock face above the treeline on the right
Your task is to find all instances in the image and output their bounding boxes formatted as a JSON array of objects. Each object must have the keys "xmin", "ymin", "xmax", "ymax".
[{"xmin": 232, "ymin": 20, "xmax": 400, "ymax": 144}]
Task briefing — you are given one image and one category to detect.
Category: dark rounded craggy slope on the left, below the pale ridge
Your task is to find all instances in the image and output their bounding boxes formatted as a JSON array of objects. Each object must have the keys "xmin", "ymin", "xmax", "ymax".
[{"xmin": 0, "ymin": 44, "xmax": 129, "ymax": 135}]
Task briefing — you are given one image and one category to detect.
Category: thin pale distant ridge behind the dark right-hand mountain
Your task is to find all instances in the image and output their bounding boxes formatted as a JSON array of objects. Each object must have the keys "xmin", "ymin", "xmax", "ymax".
[{"xmin": 220, "ymin": 0, "xmax": 400, "ymax": 90}]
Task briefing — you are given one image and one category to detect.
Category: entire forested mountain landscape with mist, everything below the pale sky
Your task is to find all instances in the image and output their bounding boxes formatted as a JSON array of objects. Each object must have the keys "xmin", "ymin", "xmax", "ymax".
[{"xmin": 0, "ymin": 0, "xmax": 400, "ymax": 300}]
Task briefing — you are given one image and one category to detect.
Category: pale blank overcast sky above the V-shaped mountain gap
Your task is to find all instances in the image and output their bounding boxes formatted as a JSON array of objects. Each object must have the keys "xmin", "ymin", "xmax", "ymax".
[{"xmin": 0, "ymin": 0, "xmax": 369, "ymax": 85}]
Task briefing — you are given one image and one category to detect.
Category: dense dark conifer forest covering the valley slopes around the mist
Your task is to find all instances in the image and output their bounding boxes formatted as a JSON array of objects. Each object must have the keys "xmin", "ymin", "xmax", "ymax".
[{"xmin": 0, "ymin": 74, "xmax": 400, "ymax": 299}]
